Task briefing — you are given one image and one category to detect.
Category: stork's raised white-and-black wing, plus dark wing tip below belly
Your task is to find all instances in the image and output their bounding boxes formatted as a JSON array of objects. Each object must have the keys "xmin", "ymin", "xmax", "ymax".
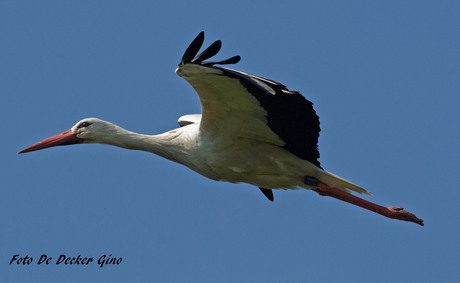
[{"xmin": 176, "ymin": 32, "xmax": 321, "ymax": 199}]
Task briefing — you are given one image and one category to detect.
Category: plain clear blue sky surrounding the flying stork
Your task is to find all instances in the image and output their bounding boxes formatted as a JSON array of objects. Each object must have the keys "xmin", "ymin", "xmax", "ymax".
[{"xmin": 0, "ymin": 0, "xmax": 460, "ymax": 282}]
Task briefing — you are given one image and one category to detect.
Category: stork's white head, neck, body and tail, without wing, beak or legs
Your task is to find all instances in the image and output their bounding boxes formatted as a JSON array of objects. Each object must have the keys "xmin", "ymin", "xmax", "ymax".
[{"xmin": 72, "ymin": 113, "xmax": 369, "ymax": 194}]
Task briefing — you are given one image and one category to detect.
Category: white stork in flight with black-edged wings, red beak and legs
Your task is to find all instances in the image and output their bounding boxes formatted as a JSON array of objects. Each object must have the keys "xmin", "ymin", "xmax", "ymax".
[{"xmin": 18, "ymin": 32, "xmax": 424, "ymax": 226}]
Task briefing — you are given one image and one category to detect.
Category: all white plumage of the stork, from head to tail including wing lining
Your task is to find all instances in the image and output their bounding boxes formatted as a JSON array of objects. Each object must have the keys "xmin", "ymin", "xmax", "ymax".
[{"xmin": 72, "ymin": 60, "xmax": 370, "ymax": 194}]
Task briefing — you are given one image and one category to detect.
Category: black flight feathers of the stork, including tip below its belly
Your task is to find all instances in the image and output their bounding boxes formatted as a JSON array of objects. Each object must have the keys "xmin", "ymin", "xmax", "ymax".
[{"xmin": 181, "ymin": 32, "xmax": 321, "ymax": 169}]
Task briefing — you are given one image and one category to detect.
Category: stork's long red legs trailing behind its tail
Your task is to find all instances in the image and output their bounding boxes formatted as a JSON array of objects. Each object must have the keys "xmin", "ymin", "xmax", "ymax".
[{"xmin": 313, "ymin": 181, "xmax": 424, "ymax": 226}]
